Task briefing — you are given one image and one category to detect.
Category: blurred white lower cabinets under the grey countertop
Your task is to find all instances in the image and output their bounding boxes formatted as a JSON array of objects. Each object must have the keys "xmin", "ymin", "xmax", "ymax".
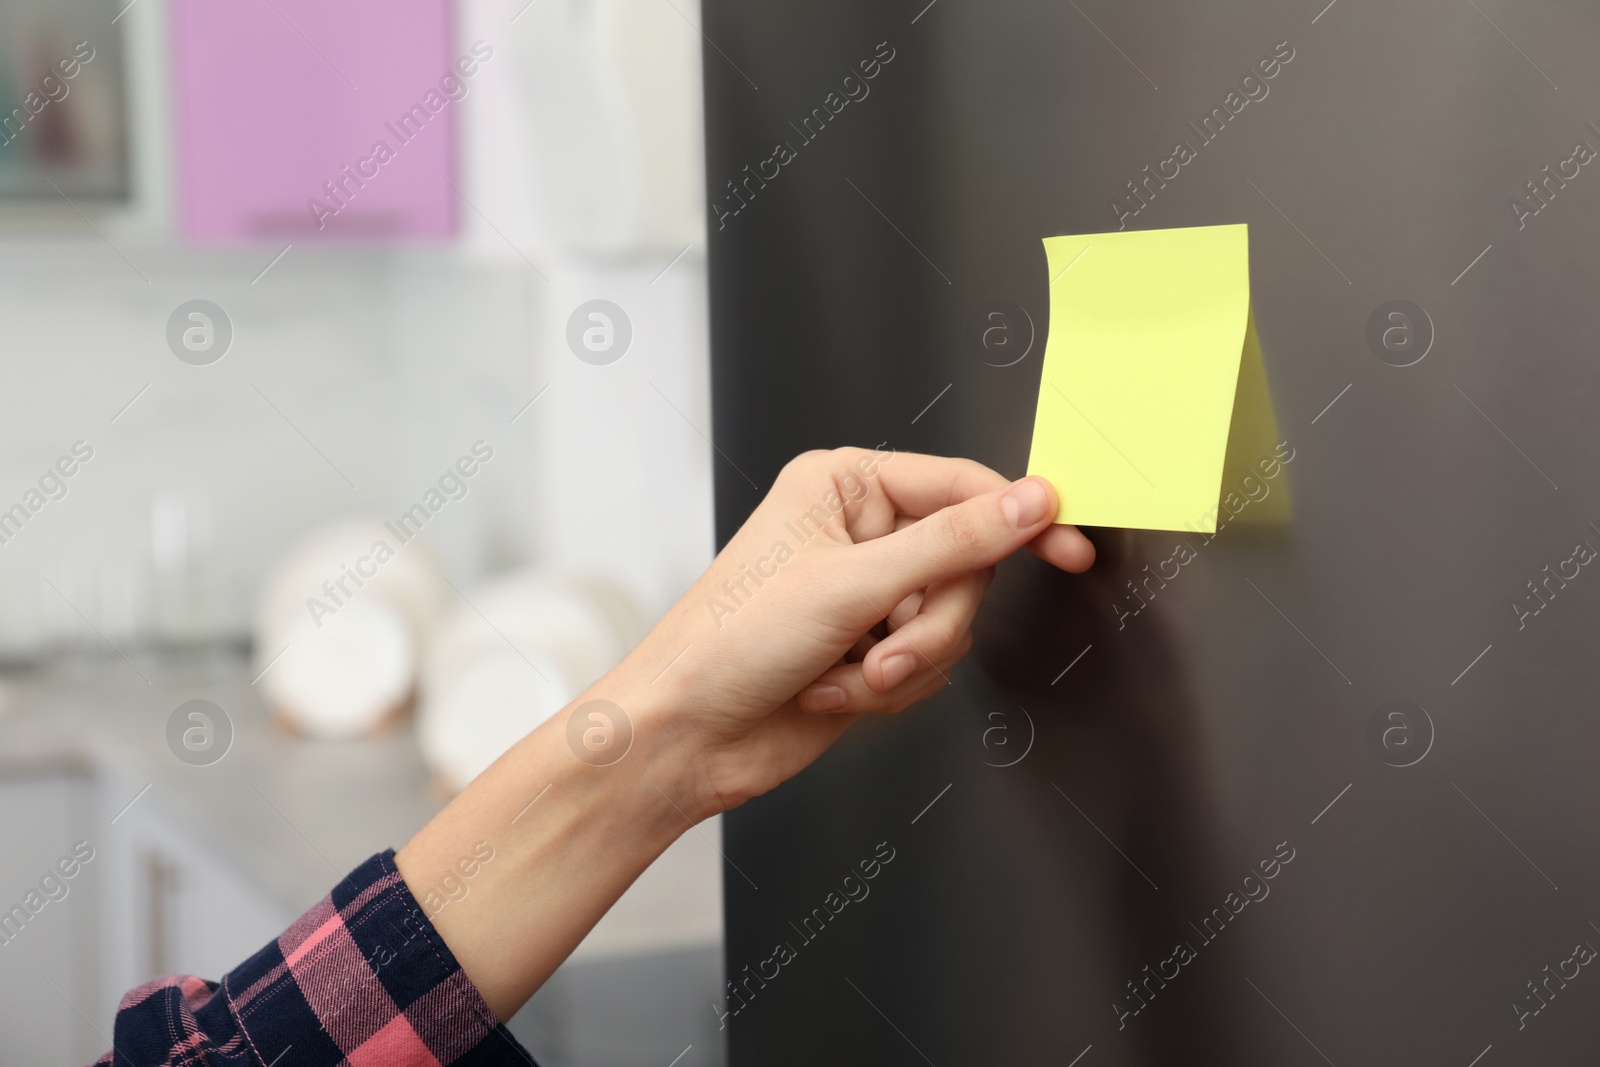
[{"xmin": 0, "ymin": 766, "xmax": 296, "ymax": 1067}]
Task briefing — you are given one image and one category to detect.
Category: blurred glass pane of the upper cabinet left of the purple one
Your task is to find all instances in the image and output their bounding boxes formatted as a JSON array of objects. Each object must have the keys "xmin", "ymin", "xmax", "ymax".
[{"xmin": 0, "ymin": 0, "xmax": 130, "ymax": 200}]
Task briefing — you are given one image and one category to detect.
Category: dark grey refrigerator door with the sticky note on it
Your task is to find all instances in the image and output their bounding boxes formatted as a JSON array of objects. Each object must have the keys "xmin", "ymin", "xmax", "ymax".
[{"xmin": 702, "ymin": 0, "xmax": 1600, "ymax": 1067}]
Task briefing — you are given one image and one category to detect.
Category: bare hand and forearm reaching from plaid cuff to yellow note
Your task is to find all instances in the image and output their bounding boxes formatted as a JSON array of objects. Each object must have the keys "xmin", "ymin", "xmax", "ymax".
[{"xmin": 395, "ymin": 448, "xmax": 1094, "ymax": 1021}]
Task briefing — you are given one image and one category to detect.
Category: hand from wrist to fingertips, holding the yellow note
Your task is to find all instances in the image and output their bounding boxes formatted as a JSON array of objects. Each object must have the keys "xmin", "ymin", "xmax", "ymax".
[{"xmin": 595, "ymin": 448, "xmax": 1094, "ymax": 817}]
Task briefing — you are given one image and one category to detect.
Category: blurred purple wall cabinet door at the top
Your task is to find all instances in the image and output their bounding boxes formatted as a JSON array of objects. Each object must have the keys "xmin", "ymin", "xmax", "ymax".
[{"xmin": 171, "ymin": 0, "xmax": 464, "ymax": 242}]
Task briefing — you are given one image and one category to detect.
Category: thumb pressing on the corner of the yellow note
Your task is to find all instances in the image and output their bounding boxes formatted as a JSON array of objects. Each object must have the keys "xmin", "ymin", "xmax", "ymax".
[{"xmin": 853, "ymin": 475, "xmax": 1059, "ymax": 605}]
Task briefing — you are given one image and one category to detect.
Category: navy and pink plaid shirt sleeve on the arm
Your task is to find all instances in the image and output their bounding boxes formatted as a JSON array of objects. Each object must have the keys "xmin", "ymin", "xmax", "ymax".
[{"xmin": 96, "ymin": 849, "xmax": 536, "ymax": 1067}]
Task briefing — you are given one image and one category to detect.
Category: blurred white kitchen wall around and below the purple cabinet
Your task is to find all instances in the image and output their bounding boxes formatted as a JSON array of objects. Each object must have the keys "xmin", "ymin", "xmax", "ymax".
[{"xmin": 0, "ymin": 0, "xmax": 712, "ymax": 659}]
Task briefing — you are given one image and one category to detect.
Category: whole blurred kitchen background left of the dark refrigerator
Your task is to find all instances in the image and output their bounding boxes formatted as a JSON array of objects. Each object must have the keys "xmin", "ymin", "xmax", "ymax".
[{"xmin": 0, "ymin": 0, "xmax": 723, "ymax": 1067}]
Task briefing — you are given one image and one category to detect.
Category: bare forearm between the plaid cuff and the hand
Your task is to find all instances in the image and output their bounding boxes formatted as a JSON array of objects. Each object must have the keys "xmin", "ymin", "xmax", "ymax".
[{"xmin": 395, "ymin": 662, "xmax": 710, "ymax": 1021}]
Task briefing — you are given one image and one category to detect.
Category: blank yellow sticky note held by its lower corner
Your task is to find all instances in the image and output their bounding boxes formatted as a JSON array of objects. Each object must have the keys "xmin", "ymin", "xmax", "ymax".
[{"xmin": 1027, "ymin": 224, "xmax": 1270, "ymax": 533}]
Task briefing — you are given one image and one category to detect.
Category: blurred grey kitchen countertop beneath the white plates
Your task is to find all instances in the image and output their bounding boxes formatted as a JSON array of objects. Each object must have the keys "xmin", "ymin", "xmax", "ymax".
[{"xmin": 0, "ymin": 672, "xmax": 722, "ymax": 960}]
